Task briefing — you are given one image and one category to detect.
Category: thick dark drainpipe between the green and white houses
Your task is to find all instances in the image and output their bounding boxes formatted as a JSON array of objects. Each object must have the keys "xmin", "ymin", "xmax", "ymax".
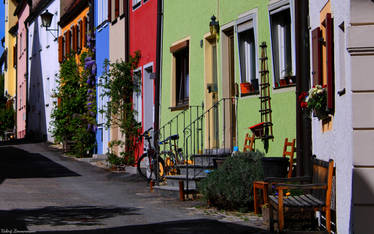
[{"xmin": 295, "ymin": 0, "xmax": 312, "ymax": 176}]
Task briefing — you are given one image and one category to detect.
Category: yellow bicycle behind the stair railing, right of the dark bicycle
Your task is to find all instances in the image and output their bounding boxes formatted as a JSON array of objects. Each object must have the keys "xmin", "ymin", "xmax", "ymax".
[{"xmin": 159, "ymin": 134, "xmax": 185, "ymax": 175}]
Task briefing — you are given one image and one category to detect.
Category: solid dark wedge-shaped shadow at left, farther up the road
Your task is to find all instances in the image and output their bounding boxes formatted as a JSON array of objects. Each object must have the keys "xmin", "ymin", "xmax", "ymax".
[{"xmin": 0, "ymin": 147, "xmax": 80, "ymax": 183}]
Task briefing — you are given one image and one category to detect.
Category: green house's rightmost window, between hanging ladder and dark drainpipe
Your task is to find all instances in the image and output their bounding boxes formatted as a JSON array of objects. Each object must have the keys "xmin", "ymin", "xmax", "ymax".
[{"xmin": 270, "ymin": 8, "xmax": 295, "ymax": 87}]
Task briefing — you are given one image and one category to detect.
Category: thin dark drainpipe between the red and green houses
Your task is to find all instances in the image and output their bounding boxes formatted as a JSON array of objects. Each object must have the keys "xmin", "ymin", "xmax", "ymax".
[{"xmin": 154, "ymin": 0, "xmax": 163, "ymax": 147}]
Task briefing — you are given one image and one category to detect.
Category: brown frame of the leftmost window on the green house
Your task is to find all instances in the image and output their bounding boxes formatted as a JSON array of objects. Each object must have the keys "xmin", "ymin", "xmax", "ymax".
[{"xmin": 170, "ymin": 38, "xmax": 191, "ymax": 111}]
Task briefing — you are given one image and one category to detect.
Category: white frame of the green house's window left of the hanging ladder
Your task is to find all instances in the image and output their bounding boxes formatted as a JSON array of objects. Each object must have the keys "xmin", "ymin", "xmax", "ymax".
[{"xmin": 235, "ymin": 13, "xmax": 260, "ymax": 84}]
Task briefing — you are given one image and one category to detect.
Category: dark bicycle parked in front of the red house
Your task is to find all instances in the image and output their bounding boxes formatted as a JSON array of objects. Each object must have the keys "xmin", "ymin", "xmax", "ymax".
[{"xmin": 136, "ymin": 127, "xmax": 165, "ymax": 181}]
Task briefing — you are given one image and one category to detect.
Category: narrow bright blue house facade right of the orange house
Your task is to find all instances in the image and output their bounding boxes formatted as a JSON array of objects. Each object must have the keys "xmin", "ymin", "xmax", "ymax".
[{"xmin": 95, "ymin": 0, "xmax": 110, "ymax": 154}]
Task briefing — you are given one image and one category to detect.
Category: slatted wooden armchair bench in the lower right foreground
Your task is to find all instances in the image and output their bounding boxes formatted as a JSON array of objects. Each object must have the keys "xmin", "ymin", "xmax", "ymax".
[{"xmin": 268, "ymin": 156, "xmax": 334, "ymax": 233}]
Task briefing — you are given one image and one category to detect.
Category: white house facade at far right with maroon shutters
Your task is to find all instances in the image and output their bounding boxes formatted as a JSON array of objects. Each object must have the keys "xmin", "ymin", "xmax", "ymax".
[{"xmin": 309, "ymin": 0, "xmax": 374, "ymax": 233}]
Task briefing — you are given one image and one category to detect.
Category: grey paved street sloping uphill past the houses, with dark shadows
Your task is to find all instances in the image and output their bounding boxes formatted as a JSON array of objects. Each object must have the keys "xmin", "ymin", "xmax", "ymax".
[{"xmin": 0, "ymin": 144, "xmax": 265, "ymax": 233}]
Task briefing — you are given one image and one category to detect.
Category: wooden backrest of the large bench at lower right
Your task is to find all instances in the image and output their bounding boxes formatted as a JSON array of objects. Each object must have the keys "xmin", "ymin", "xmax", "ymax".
[{"xmin": 312, "ymin": 155, "xmax": 334, "ymax": 207}]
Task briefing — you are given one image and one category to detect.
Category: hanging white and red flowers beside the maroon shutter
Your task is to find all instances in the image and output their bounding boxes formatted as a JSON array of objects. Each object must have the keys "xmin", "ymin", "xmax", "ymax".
[{"xmin": 299, "ymin": 85, "xmax": 329, "ymax": 120}]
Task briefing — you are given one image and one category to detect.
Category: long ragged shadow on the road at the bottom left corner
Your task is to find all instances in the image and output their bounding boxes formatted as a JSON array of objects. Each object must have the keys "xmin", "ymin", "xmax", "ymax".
[{"xmin": 0, "ymin": 206, "xmax": 138, "ymax": 231}]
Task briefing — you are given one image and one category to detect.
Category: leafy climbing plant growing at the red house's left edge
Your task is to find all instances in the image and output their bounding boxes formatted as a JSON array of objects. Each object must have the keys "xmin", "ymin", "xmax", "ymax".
[{"xmin": 100, "ymin": 52, "xmax": 141, "ymax": 165}]
